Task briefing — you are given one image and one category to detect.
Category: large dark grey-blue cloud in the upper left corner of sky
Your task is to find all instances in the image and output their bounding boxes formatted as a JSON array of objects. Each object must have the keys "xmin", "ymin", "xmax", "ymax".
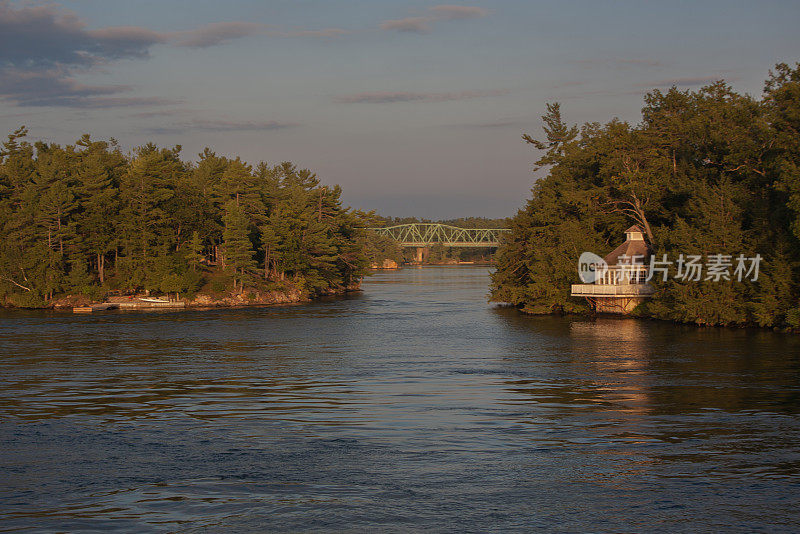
[{"xmin": 0, "ymin": 0, "xmax": 347, "ymax": 108}]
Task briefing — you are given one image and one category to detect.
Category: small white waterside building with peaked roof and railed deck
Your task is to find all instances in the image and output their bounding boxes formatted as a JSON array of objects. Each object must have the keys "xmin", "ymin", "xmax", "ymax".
[{"xmin": 572, "ymin": 226, "xmax": 654, "ymax": 314}]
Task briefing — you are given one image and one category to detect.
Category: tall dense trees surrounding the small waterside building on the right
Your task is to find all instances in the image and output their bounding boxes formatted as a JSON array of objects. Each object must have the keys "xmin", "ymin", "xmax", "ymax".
[{"xmin": 492, "ymin": 64, "xmax": 800, "ymax": 328}]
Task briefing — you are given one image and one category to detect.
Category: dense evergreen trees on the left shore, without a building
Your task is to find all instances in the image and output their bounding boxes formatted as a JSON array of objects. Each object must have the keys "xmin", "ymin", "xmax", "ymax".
[{"xmin": 0, "ymin": 134, "xmax": 368, "ymax": 306}]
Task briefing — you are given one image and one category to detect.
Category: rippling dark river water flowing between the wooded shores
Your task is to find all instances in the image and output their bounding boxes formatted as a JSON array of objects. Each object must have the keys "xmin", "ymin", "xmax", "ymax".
[{"xmin": 0, "ymin": 267, "xmax": 800, "ymax": 532}]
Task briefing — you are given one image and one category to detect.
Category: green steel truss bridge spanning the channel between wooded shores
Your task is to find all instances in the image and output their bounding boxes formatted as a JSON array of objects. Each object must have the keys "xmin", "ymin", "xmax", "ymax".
[{"xmin": 369, "ymin": 223, "xmax": 510, "ymax": 248}]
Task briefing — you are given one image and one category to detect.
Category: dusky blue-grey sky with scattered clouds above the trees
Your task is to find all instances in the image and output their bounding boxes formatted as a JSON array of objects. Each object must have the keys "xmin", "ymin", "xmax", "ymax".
[{"xmin": 0, "ymin": 0, "xmax": 800, "ymax": 219}]
